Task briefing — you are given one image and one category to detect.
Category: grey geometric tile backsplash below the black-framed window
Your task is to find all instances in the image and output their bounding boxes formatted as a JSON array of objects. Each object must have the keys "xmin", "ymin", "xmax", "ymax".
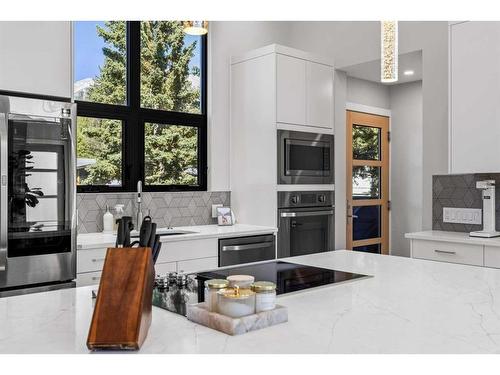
[{"xmin": 76, "ymin": 191, "xmax": 231, "ymax": 233}]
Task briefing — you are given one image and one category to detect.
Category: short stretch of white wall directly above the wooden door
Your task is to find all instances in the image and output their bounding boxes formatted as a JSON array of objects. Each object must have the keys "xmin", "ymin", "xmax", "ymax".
[{"xmin": 347, "ymin": 77, "xmax": 391, "ymax": 109}]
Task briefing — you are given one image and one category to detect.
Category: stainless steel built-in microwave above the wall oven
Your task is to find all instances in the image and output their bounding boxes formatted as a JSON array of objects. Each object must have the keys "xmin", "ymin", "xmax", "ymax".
[{"xmin": 278, "ymin": 130, "xmax": 334, "ymax": 184}]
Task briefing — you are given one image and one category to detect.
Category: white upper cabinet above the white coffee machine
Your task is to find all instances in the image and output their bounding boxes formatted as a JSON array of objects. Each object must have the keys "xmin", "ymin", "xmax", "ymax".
[{"xmin": 450, "ymin": 22, "xmax": 500, "ymax": 173}]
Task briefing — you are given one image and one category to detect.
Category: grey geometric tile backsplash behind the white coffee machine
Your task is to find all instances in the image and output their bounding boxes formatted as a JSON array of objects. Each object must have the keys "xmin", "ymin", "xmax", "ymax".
[{"xmin": 432, "ymin": 173, "xmax": 500, "ymax": 232}]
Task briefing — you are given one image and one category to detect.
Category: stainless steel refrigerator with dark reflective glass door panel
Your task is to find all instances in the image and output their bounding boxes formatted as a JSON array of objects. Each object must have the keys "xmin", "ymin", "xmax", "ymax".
[{"xmin": 0, "ymin": 96, "xmax": 76, "ymax": 296}]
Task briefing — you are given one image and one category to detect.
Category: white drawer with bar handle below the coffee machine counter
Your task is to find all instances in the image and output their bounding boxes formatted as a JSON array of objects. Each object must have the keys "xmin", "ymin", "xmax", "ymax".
[{"xmin": 412, "ymin": 240, "xmax": 483, "ymax": 266}]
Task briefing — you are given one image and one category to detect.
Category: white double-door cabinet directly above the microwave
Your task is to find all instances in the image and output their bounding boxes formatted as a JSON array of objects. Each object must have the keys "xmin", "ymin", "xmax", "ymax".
[{"xmin": 276, "ymin": 54, "xmax": 333, "ymax": 129}]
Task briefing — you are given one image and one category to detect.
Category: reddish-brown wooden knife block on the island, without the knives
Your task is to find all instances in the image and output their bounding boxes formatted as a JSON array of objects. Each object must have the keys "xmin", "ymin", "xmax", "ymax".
[{"xmin": 87, "ymin": 247, "xmax": 154, "ymax": 350}]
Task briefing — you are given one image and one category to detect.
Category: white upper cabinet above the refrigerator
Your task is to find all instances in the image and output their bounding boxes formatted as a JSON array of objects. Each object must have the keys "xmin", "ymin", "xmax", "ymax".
[{"xmin": 0, "ymin": 21, "xmax": 71, "ymax": 98}]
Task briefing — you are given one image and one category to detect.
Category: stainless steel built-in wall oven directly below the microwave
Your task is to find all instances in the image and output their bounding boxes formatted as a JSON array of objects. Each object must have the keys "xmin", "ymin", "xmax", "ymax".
[{"xmin": 278, "ymin": 191, "xmax": 335, "ymax": 258}]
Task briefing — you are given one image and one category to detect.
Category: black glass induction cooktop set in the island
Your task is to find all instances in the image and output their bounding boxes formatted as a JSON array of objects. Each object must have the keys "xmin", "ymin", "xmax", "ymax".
[{"xmin": 197, "ymin": 260, "xmax": 368, "ymax": 300}]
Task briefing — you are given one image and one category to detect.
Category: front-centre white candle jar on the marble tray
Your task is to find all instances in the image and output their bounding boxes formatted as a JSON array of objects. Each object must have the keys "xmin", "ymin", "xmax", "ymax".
[{"xmin": 217, "ymin": 287, "xmax": 255, "ymax": 318}]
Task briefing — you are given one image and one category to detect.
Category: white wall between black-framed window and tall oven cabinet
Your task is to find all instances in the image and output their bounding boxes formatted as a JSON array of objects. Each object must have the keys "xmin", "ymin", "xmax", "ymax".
[{"xmin": 208, "ymin": 21, "xmax": 290, "ymax": 191}]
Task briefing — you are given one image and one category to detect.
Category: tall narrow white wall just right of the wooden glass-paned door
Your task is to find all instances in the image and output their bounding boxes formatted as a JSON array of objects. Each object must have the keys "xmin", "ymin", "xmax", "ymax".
[{"xmin": 389, "ymin": 81, "xmax": 423, "ymax": 256}]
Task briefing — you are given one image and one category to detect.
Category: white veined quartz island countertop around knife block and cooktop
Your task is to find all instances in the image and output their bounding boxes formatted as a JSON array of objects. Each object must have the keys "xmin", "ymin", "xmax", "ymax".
[{"xmin": 0, "ymin": 250, "xmax": 500, "ymax": 353}]
